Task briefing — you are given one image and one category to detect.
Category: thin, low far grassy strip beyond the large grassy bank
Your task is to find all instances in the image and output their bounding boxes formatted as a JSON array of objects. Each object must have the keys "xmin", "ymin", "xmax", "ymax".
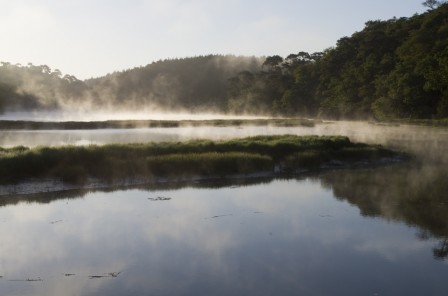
[{"xmin": 0, "ymin": 118, "xmax": 316, "ymax": 130}]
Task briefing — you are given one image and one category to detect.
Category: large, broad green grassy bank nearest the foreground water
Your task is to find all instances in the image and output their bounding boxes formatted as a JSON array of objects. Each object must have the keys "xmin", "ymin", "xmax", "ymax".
[{"xmin": 0, "ymin": 135, "xmax": 395, "ymax": 184}]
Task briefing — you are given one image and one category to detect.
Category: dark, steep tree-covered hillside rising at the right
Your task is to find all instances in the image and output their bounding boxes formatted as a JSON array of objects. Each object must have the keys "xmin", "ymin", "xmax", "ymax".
[{"xmin": 229, "ymin": 4, "xmax": 448, "ymax": 119}]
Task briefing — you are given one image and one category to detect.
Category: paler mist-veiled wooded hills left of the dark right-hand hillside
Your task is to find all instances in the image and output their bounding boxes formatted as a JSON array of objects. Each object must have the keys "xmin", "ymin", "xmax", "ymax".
[{"xmin": 0, "ymin": 55, "xmax": 263, "ymax": 113}]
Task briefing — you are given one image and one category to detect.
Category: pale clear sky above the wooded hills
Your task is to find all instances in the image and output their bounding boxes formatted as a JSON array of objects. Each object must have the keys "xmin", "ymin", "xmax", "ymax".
[{"xmin": 0, "ymin": 0, "xmax": 426, "ymax": 79}]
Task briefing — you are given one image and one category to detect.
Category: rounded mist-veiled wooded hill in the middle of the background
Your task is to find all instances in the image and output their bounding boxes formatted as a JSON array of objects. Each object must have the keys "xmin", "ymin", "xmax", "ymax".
[{"xmin": 86, "ymin": 55, "xmax": 263, "ymax": 112}]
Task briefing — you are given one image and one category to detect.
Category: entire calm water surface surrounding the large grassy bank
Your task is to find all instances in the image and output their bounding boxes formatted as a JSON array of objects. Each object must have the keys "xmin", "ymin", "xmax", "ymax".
[{"xmin": 0, "ymin": 122, "xmax": 448, "ymax": 295}]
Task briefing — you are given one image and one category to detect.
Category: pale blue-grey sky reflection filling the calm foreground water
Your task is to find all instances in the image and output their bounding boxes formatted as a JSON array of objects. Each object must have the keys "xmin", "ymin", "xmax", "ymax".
[{"xmin": 0, "ymin": 180, "xmax": 448, "ymax": 296}]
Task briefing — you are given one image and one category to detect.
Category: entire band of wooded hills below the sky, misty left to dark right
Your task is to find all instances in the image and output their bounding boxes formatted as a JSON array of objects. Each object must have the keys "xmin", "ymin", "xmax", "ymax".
[{"xmin": 0, "ymin": 1, "xmax": 448, "ymax": 120}]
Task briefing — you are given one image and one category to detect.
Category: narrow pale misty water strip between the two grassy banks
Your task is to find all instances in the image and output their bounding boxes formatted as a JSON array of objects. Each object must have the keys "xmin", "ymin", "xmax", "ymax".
[{"xmin": 0, "ymin": 122, "xmax": 448, "ymax": 149}]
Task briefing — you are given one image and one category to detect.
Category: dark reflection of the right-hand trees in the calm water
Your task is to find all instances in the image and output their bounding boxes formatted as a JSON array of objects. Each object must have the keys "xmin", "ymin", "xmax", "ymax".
[{"xmin": 321, "ymin": 163, "xmax": 448, "ymax": 259}]
